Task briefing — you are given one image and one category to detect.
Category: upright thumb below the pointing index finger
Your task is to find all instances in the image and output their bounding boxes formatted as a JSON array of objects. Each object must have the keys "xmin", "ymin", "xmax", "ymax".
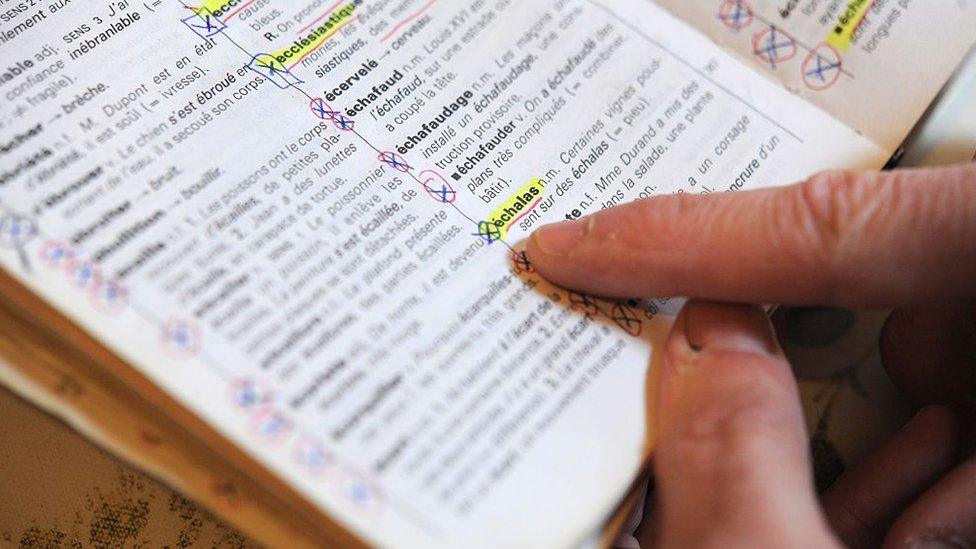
[{"xmin": 654, "ymin": 302, "xmax": 838, "ymax": 547}]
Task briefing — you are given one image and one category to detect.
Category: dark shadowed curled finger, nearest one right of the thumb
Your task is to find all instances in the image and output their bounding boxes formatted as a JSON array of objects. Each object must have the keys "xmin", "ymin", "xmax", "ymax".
[{"xmin": 822, "ymin": 406, "xmax": 958, "ymax": 549}]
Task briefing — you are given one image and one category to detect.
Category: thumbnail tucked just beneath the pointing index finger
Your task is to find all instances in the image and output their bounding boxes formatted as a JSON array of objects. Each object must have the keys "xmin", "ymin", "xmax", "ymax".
[{"xmin": 684, "ymin": 301, "xmax": 779, "ymax": 355}]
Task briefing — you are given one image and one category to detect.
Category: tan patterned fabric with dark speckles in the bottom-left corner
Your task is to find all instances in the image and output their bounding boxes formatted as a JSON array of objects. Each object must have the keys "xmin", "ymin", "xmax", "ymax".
[{"xmin": 0, "ymin": 389, "xmax": 256, "ymax": 549}]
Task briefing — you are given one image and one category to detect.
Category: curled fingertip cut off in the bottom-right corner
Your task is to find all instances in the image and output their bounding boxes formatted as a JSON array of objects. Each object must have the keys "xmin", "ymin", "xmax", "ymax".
[{"xmin": 884, "ymin": 459, "xmax": 976, "ymax": 549}]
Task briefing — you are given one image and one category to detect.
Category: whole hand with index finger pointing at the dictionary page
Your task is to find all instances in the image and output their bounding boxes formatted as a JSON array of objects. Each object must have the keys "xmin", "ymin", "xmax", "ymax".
[{"xmin": 528, "ymin": 165, "xmax": 976, "ymax": 547}]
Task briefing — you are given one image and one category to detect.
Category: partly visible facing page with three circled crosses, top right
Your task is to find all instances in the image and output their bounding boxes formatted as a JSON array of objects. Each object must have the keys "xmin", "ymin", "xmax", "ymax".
[{"xmin": 657, "ymin": 0, "xmax": 976, "ymax": 151}]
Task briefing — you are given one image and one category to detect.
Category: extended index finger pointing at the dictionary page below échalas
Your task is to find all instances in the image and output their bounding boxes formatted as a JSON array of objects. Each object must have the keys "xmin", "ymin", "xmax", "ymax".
[{"xmin": 528, "ymin": 165, "xmax": 976, "ymax": 306}]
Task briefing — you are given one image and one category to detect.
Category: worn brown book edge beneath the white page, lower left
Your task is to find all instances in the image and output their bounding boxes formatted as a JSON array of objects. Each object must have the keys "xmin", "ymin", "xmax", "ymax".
[{"xmin": 0, "ymin": 269, "xmax": 366, "ymax": 547}]
